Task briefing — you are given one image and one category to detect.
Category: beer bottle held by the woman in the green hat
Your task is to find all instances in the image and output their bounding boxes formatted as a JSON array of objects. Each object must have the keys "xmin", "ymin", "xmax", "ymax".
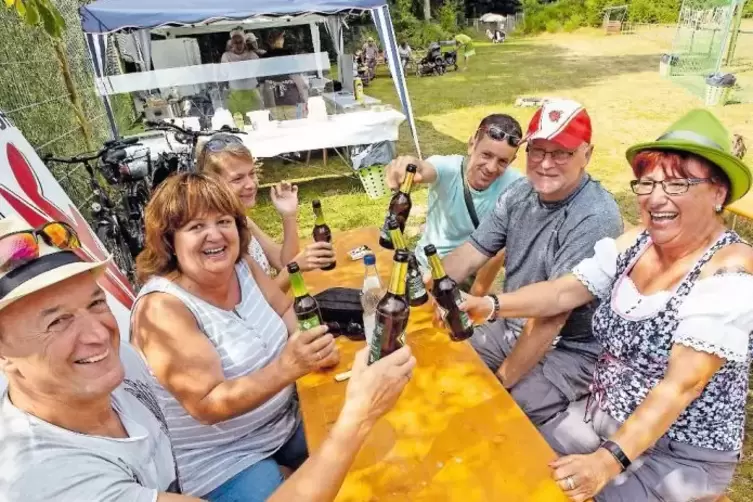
[{"xmin": 424, "ymin": 244, "xmax": 473, "ymax": 342}]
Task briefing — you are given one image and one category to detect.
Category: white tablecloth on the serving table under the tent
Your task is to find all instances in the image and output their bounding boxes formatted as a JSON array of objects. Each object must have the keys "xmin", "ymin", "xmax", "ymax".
[{"xmin": 239, "ymin": 109, "xmax": 405, "ymax": 158}]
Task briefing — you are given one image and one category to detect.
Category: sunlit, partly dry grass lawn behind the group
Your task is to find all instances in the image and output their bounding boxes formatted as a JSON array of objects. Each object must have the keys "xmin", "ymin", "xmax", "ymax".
[{"xmin": 253, "ymin": 30, "xmax": 753, "ymax": 502}]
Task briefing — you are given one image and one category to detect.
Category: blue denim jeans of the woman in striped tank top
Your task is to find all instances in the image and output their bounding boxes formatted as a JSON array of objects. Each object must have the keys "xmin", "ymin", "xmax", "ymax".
[{"xmin": 204, "ymin": 424, "xmax": 308, "ymax": 502}]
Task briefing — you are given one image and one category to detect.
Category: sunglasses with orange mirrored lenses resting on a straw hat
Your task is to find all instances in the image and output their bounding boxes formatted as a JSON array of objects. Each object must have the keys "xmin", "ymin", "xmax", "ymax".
[{"xmin": 0, "ymin": 221, "xmax": 81, "ymax": 273}]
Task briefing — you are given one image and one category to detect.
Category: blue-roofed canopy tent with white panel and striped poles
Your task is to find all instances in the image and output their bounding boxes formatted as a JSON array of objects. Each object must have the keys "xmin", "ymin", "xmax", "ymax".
[{"xmin": 80, "ymin": 0, "xmax": 421, "ymax": 156}]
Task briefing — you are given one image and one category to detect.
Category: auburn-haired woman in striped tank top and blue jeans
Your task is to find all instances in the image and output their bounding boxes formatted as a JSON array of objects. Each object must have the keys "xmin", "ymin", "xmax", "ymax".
[{"xmin": 131, "ymin": 173, "xmax": 339, "ymax": 502}]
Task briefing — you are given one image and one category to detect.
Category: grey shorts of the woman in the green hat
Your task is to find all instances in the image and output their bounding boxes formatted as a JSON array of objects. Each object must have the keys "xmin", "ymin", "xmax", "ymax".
[{"xmin": 539, "ymin": 399, "xmax": 740, "ymax": 502}]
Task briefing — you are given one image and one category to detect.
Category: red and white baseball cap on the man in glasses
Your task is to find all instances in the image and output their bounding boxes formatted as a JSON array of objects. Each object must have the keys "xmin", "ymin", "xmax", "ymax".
[{"xmin": 525, "ymin": 99, "xmax": 591, "ymax": 150}]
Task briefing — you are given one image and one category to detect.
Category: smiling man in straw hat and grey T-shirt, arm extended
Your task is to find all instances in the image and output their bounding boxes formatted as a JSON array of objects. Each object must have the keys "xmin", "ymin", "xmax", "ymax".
[{"xmin": 0, "ymin": 216, "xmax": 415, "ymax": 502}]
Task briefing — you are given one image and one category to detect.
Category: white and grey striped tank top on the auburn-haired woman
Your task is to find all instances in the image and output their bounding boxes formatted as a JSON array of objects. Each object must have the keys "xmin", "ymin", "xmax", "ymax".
[{"xmin": 134, "ymin": 260, "xmax": 299, "ymax": 497}]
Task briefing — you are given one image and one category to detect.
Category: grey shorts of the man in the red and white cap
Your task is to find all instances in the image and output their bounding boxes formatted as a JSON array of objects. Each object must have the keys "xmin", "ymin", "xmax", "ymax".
[{"xmin": 471, "ymin": 319, "xmax": 596, "ymax": 426}]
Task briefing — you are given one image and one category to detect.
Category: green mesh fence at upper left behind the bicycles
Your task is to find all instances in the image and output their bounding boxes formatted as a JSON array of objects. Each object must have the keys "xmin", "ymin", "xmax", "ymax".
[{"xmin": 0, "ymin": 0, "xmax": 133, "ymax": 210}]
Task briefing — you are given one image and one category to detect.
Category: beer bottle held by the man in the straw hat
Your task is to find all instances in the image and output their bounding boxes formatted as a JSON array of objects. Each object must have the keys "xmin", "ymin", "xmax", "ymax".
[{"xmin": 369, "ymin": 249, "xmax": 410, "ymax": 364}]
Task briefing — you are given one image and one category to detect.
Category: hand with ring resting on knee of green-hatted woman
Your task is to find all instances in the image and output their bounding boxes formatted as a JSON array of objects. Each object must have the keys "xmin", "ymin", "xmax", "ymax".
[{"xmin": 549, "ymin": 448, "xmax": 621, "ymax": 502}]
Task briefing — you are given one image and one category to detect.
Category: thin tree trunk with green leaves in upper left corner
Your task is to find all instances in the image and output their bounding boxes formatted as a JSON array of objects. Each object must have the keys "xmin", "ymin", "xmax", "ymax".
[{"xmin": 4, "ymin": 0, "xmax": 94, "ymax": 150}]
